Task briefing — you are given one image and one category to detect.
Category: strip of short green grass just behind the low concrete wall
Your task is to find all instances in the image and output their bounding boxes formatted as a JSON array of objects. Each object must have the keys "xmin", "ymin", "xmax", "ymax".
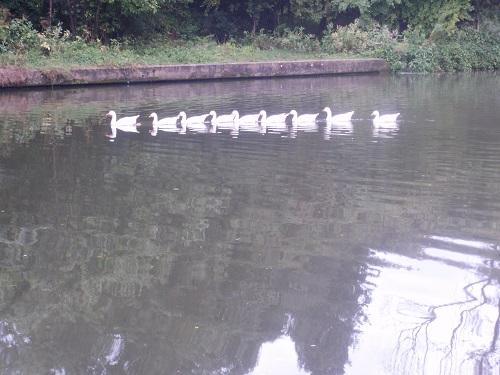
[{"xmin": 0, "ymin": 37, "xmax": 341, "ymax": 68}]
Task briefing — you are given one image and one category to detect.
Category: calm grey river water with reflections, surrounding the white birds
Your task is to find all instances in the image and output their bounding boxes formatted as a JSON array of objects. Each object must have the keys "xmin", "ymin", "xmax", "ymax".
[{"xmin": 0, "ymin": 73, "xmax": 500, "ymax": 375}]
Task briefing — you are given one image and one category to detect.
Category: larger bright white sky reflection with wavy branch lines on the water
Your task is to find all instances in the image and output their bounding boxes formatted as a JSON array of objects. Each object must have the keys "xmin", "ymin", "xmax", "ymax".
[{"xmin": 346, "ymin": 241, "xmax": 500, "ymax": 375}]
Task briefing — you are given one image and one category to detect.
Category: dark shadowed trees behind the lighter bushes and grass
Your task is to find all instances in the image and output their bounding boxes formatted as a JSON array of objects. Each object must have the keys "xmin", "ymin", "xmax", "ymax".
[{"xmin": 3, "ymin": 0, "xmax": 498, "ymax": 41}]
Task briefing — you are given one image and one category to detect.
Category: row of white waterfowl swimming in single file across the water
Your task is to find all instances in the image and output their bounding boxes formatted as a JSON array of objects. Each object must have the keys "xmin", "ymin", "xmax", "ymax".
[{"xmin": 106, "ymin": 107, "xmax": 399, "ymax": 139}]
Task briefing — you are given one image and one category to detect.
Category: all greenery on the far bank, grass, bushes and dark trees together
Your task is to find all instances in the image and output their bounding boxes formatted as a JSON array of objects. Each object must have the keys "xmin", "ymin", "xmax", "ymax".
[{"xmin": 0, "ymin": 0, "xmax": 500, "ymax": 72}]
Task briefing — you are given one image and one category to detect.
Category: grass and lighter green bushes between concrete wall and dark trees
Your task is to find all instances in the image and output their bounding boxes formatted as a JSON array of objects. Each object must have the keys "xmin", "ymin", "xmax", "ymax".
[{"xmin": 0, "ymin": 20, "xmax": 500, "ymax": 72}]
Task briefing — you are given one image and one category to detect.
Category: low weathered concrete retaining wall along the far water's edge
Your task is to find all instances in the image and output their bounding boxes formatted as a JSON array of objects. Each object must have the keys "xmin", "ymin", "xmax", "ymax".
[{"xmin": 0, "ymin": 59, "xmax": 388, "ymax": 87}]
